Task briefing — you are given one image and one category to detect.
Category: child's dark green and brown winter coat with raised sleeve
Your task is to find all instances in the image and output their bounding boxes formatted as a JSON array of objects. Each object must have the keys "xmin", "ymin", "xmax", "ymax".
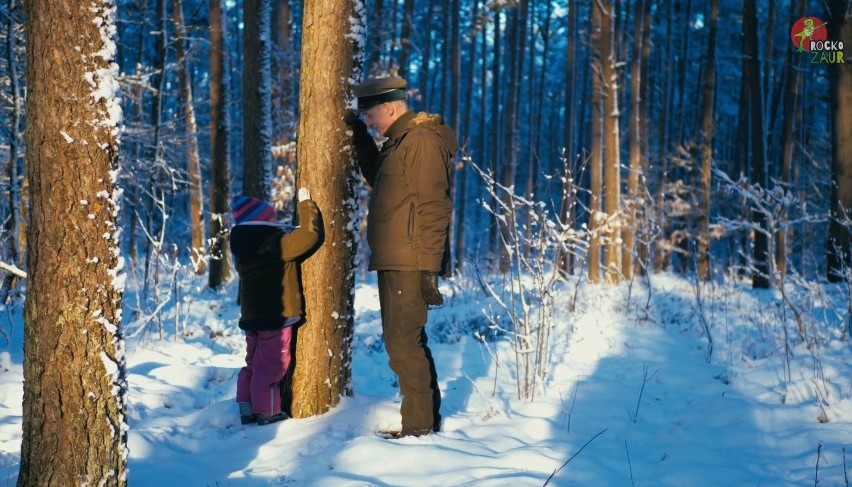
[{"xmin": 230, "ymin": 200, "xmax": 322, "ymax": 330}]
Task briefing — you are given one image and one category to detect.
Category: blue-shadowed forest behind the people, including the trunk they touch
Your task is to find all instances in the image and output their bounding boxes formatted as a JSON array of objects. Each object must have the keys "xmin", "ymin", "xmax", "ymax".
[{"xmin": 0, "ymin": 0, "xmax": 852, "ymax": 486}]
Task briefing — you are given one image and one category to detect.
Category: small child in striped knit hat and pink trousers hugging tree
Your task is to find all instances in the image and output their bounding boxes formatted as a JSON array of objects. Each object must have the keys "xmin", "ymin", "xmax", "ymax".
[{"xmin": 230, "ymin": 188, "xmax": 321, "ymax": 424}]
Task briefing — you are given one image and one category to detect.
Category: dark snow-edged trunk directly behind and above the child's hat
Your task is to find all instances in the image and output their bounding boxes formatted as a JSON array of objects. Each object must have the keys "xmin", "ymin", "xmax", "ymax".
[{"xmin": 242, "ymin": 0, "xmax": 272, "ymax": 200}]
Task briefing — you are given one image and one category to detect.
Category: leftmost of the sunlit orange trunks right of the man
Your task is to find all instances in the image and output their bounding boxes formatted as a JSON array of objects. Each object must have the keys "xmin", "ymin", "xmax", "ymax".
[{"xmin": 589, "ymin": 2, "xmax": 605, "ymax": 284}]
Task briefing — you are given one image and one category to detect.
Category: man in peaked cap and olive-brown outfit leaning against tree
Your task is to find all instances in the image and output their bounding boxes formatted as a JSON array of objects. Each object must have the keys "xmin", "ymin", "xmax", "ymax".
[{"xmin": 346, "ymin": 76, "xmax": 458, "ymax": 436}]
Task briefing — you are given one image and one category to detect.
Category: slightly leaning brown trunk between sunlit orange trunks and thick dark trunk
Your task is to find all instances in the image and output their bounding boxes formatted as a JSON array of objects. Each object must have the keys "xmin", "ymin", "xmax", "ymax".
[{"xmin": 698, "ymin": 0, "xmax": 719, "ymax": 281}]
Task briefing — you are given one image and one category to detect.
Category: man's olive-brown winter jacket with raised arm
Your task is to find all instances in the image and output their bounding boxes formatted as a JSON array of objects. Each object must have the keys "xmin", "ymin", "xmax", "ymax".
[{"xmin": 352, "ymin": 111, "xmax": 458, "ymax": 275}]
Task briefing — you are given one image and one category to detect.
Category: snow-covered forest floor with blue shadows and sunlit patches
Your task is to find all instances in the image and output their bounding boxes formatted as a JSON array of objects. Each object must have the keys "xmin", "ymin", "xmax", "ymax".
[{"xmin": 0, "ymin": 275, "xmax": 852, "ymax": 487}]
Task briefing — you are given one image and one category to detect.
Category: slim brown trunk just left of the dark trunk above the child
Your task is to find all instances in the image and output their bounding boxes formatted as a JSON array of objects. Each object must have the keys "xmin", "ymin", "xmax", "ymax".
[{"xmin": 207, "ymin": 0, "xmax": 231, "ymax": 289}]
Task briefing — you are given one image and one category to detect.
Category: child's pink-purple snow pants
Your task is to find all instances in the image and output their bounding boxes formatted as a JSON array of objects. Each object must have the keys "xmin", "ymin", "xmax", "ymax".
[{"xmin": 237, "ymin": 326, "xmax": 293, "ymax": 416}]
